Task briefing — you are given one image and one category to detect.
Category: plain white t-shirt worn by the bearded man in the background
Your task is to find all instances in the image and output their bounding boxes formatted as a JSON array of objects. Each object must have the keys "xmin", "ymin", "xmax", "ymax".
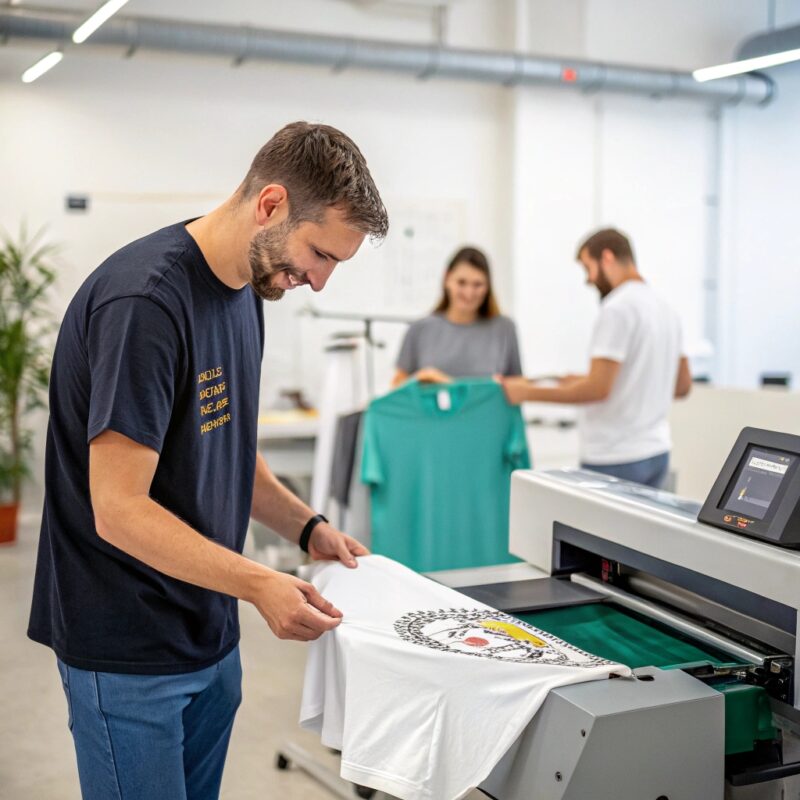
[{"xmin": 581, "ymin": 281, "xmax": 683, "ymax": 464}]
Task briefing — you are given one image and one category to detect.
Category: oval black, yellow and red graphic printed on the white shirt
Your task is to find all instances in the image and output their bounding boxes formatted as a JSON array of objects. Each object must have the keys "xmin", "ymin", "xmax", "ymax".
[{"xmin": 394, "ymin": 608, "xmax": 614, "ymax": 667}]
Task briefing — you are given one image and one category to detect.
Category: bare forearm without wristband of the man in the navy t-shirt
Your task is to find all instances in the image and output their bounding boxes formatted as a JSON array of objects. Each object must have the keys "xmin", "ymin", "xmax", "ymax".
[{"xmin": 96, "ymin": 495, "xmax": 275, "ymax": 602}]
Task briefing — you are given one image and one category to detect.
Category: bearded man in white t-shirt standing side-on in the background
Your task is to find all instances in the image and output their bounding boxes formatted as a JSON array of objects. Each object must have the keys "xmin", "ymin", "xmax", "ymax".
[{"xmin": 503, "ymin": 228, "xmax": 692, "ymax": 487}]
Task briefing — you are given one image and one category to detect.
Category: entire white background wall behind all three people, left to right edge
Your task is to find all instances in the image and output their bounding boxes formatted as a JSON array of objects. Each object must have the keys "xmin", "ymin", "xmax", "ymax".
[{"xmin": 0, "ymin": 0, "xmax": 800, "ymax": 506}]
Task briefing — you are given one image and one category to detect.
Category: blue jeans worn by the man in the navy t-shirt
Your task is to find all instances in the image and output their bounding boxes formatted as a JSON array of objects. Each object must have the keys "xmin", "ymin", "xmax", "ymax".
[{"xmin": 58, "ymin": 647, "xmax": 242, "ymax": 800}]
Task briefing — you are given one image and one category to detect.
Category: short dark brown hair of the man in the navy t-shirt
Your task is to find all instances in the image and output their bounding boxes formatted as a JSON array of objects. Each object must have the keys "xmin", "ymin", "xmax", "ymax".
[{"xmin": 238, "ymin": 122, "xmax": 389, "ymax": 241}]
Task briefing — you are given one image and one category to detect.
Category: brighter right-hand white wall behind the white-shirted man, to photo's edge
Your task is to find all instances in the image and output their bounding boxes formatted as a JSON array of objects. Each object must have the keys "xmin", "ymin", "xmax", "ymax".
[{"xmin": 512, "ymin": 0, "xmax": 800, "ymax": 386}]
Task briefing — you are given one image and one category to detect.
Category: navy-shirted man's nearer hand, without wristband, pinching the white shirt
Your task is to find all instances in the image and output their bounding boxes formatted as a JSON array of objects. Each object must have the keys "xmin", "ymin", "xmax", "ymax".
[{"xmin": 251, "ymin": 572, "xmax": 342, "ymax": 642}]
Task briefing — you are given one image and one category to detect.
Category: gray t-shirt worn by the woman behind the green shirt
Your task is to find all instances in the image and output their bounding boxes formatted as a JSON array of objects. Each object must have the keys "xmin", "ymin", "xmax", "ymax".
[{"xmin": 397, "ymin": 313, "xmax": 522, "ymax": 378}]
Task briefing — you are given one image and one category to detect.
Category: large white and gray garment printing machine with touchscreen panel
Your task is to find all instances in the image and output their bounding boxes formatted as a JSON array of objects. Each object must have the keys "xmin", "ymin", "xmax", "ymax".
[{"xmin": 444, "ymin": 428, "xmax": 800, "ymax": 800}]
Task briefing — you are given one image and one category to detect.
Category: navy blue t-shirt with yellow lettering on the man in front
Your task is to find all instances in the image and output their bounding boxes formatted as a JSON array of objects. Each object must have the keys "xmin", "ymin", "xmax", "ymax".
[{"xmin": 28, "ymin": 223, "xmax": 264, "ymax": 674}]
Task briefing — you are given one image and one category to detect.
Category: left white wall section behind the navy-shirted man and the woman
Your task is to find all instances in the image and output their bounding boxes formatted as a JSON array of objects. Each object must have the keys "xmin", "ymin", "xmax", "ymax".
[{"xmin": 0, "ymin": 0, "xmax": 510, "ymax": 412}]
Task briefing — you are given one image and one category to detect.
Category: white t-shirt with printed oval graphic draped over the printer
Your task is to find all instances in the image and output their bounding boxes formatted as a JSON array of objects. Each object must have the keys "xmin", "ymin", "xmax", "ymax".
[{"xmin": 300, "ymin": 556, "xmax": 630, "ymax": 800}]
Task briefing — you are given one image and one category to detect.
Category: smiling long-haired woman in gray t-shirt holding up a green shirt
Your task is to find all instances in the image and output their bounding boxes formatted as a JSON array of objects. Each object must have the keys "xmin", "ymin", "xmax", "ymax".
[{"xmin": 392, "ymin": 247, "xmax": 522, "ymax": 386}]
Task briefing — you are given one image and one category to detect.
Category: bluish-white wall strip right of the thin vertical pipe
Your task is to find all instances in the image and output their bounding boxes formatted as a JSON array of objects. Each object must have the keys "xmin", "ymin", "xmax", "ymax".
[{"xmin": 720, "ymin": 64, "xmax": 800, "ymax": 388}]
